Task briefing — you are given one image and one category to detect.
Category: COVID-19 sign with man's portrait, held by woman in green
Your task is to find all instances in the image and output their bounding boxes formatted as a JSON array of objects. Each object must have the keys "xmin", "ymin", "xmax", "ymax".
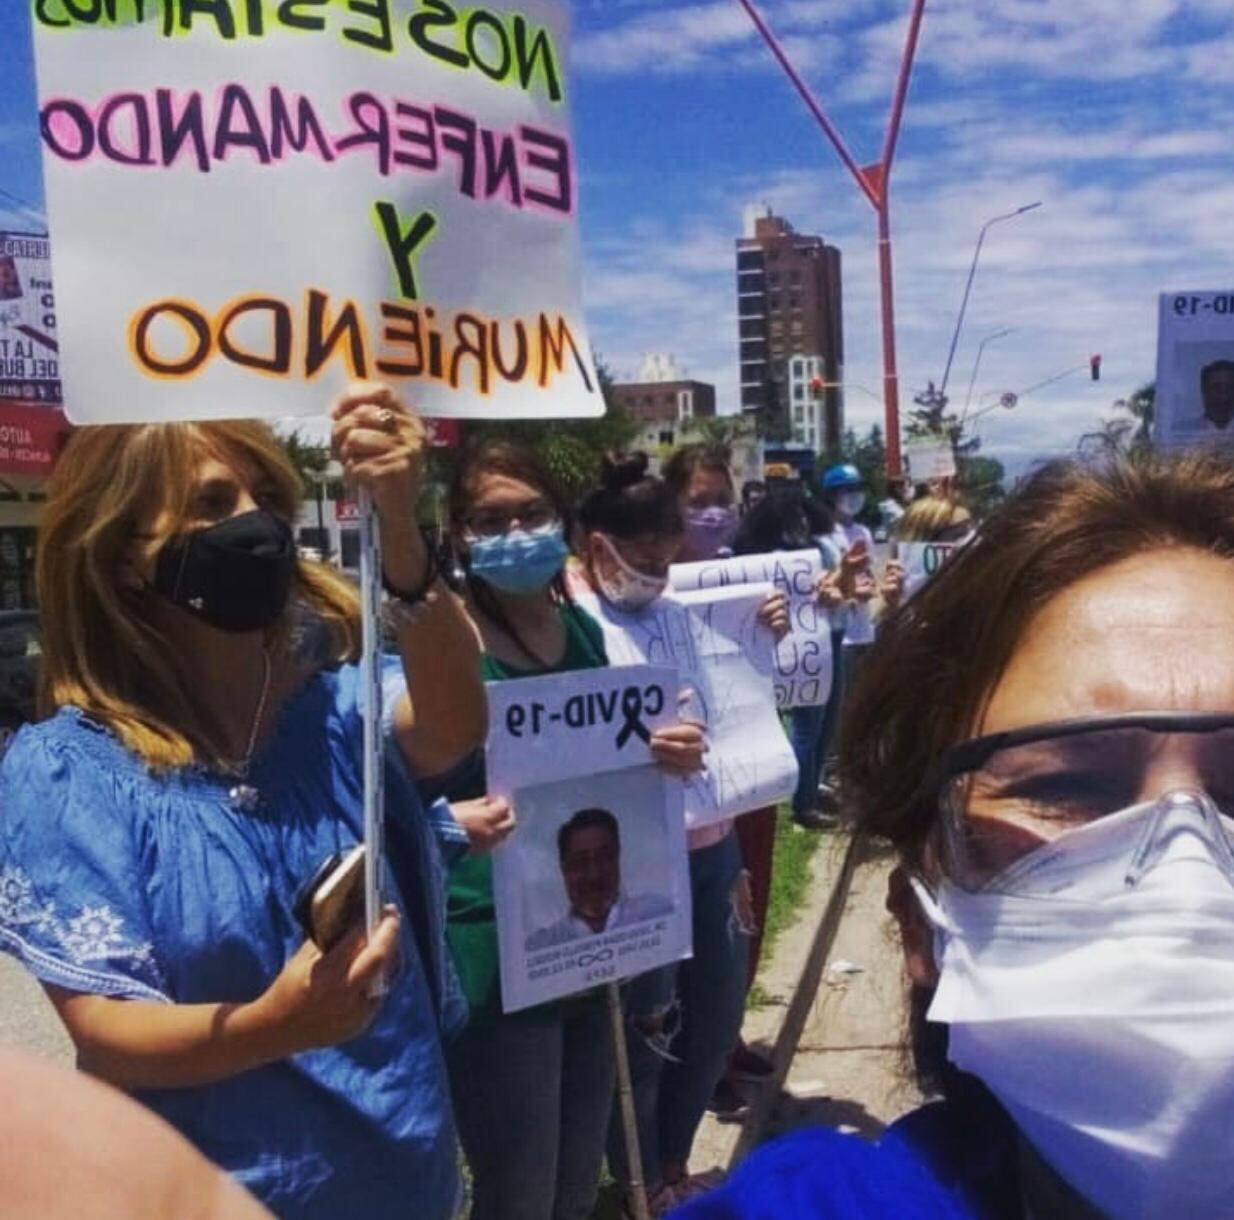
[{"xmin": 487, "ymin": 665, "xmax": 691, "ymax": 1013}]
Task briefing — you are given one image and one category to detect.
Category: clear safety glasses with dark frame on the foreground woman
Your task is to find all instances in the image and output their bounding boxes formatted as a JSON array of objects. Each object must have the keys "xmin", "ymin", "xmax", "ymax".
[{"xmin": 930, "ymin": 712, "xmax": 1234, "ymax": 889}]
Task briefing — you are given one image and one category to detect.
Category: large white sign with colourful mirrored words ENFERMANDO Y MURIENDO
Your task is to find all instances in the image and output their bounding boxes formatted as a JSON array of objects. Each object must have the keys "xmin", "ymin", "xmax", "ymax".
[{"xmin": 32, "ymin": 0, "xmax": 603, "ymax": 423}]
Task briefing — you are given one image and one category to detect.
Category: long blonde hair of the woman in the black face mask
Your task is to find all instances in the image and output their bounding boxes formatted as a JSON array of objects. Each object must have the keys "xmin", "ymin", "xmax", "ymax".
[{"xmin": 35, "ymin": 421, "xmax": 359, "ymax": 769}]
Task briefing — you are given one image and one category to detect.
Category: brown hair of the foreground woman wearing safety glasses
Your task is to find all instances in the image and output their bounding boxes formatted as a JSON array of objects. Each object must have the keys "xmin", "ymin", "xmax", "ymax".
[{"xmin": 840, "ymin": 453, "xmax": 1234, "ymax": 866}]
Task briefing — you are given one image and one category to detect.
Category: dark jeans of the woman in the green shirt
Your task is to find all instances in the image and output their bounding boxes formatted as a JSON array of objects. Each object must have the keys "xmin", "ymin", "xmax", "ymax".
[{"xmin": 446, "ymin": 995, "xmax": 615, "ymax": 1220}]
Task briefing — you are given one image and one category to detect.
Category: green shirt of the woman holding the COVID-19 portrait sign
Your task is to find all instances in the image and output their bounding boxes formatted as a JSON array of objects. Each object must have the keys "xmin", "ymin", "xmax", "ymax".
[{"xmin": 445, "ymin": 603, "xmax": 608, "ymax": 1021}]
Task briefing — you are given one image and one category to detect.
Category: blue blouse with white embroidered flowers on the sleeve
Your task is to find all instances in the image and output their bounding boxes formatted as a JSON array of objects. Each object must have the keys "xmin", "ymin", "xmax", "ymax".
[{"xmin": 0, "ymin": 659, "xmax": 465, "ymax": 1220}]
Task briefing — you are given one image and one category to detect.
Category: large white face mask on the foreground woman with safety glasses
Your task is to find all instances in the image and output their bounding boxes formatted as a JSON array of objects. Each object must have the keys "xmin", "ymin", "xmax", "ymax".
[{"xmin": 914, "ymin": 792, "xmax": 1234, "ymax": 1220}]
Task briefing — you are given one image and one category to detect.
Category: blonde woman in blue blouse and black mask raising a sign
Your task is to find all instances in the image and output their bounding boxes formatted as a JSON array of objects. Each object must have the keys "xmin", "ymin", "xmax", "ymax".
[{"xmin": 0, "ymin": 375, "xmax": 485, "ymax": 1220}]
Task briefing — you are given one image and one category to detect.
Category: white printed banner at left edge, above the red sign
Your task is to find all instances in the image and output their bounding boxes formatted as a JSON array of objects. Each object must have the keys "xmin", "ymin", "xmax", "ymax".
[{"xmin": 0, "ymin": 233, "xmax": 62, "ymax": 406}]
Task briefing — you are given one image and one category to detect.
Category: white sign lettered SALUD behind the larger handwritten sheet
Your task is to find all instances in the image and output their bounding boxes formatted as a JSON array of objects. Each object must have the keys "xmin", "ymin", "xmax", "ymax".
[{"xmin": 669, "ymin": 550, "xmax": 832, "ymax": 709}]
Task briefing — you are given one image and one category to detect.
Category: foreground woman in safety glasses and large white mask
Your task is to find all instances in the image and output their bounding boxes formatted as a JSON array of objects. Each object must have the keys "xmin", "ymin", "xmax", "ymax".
[{"xmin": 680, "ymin": 455, "xmax": 1234, "ymax": 1220}]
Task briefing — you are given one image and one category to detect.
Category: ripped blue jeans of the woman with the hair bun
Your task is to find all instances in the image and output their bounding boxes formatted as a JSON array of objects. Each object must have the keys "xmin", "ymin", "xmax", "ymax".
[{"xmin": 608, "ymin": 833, "xmax": 749, "ymax": 1190}]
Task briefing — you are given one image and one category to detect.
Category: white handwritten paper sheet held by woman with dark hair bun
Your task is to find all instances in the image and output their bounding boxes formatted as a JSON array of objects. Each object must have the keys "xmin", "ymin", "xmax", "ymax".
[{"xmin": 580, "ymin": 585, "xmax": 797, "ymax": 828}]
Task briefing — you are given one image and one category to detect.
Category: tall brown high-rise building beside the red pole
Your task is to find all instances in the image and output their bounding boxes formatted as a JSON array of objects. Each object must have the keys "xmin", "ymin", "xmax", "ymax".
[{"xmin": 737, "ymin": 207, "xmax": 844, "ymax": 451}]
